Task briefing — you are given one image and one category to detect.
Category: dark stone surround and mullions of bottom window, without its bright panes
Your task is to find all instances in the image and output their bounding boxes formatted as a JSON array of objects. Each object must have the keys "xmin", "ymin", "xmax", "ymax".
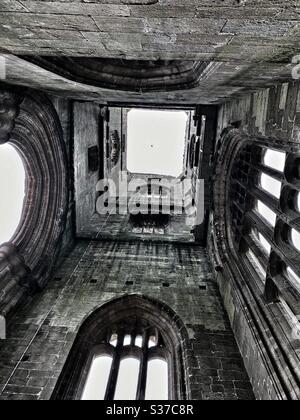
[{"xmin": 51, "ymin": 294, "xmax": 189, "ymax": 400}]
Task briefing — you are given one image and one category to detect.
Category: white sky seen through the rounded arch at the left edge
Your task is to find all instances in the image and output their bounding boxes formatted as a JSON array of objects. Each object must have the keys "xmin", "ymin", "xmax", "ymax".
[{"xmin": 0, "ymin": 144, "xmax": 25, "ymax": 244}]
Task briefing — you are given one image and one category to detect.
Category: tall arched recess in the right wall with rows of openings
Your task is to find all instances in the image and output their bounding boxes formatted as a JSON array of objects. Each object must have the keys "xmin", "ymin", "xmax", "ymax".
[{"xmin": 210, "ymin": 127, "xmax": 300, "ymax": 400}]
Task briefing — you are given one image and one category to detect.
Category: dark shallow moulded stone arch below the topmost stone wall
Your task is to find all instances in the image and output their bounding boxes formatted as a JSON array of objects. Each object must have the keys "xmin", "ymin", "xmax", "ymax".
[{"xmin": 26, "ymin": 57, "xmax": 210, "ymax": 93}]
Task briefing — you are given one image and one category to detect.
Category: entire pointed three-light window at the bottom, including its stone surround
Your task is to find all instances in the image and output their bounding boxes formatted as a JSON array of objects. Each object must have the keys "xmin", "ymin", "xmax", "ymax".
[{"xmin": 52, "ymin": 295, "xmax": 186, "ymax": 400}]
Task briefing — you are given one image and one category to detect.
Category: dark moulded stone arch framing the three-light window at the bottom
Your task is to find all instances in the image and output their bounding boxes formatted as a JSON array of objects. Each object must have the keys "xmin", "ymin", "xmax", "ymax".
[{"xmin": 51, "ymin": 294, "xmax": 190, "ymax": 400}]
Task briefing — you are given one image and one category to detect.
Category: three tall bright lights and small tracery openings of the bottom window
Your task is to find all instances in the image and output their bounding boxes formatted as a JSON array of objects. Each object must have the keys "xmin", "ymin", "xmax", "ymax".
[{"xmin": 81, "ymin": 317, "xmax": 170, "ymax": 400}]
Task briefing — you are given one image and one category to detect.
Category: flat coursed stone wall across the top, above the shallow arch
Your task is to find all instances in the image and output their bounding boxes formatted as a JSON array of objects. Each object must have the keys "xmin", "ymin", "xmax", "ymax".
[{"xmin": 0, "ymin": 0, "xmax": 299, "ymax": 62}]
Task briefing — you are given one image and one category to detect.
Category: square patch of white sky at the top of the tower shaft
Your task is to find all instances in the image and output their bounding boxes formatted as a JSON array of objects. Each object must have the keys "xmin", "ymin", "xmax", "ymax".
[{"xmin": 127, "ymin": 109, "xmax": 188, "ymax": 177}]
